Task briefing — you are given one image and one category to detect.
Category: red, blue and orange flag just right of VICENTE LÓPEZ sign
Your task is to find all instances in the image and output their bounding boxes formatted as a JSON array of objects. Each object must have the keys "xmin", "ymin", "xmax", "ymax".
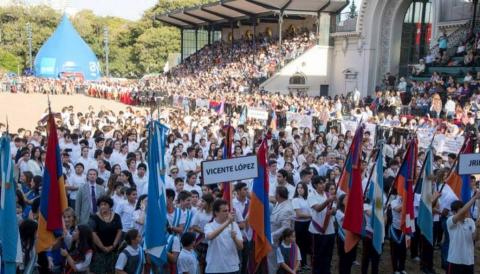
[{"xmin": 248, "ymin": 139, "xmax": 272, "ymax": 266}]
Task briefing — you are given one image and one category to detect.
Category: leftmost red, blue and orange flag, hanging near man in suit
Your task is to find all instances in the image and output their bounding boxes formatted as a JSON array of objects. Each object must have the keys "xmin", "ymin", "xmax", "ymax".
[{"xmin": 36, "ymin": 113, "xmax": 67, "ymax": 252}]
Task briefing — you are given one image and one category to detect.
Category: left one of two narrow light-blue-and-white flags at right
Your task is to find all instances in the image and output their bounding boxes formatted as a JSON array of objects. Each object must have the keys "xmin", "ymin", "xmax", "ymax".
[{"xmin": 370, "ymin": 148, "xmax": 385, "ymax": 254}]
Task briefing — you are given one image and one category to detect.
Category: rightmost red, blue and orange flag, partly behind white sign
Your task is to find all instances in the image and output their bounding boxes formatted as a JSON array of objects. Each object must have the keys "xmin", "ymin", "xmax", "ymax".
[{"xmin": 446, "ymin": 136, "xmax": 473, "ymax": 203}]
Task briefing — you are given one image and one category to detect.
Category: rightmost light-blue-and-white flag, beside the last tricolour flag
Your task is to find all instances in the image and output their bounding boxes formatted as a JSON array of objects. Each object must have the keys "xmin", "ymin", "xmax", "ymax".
[{"xmin": 417, "ymin": 146, "xmax": 433, "ymax": 245}]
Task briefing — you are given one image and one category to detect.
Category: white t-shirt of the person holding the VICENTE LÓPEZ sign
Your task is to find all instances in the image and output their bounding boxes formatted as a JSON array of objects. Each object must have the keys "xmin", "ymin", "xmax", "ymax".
[{"xmin": 205, "ymin": 220, "xmax": 243, "ymax": 273}]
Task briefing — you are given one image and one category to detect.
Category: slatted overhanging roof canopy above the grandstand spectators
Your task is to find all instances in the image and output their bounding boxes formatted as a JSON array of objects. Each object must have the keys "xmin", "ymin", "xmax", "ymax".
[{"xmin": 155, "ymin": 0, "xmax": 349, "ymax": 28}]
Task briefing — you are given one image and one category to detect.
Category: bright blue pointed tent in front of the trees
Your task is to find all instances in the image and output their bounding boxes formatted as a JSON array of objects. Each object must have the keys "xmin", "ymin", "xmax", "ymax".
[{"xmin": 35, "ymin": 15, "xmax": 101, "ymax": 80}]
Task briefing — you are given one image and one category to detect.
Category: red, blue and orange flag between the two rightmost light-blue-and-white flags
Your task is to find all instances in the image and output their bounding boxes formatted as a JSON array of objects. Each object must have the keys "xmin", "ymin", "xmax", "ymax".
[{"xmin": 394, "ymin": 138, "xmax": 418, "ymax": 245}]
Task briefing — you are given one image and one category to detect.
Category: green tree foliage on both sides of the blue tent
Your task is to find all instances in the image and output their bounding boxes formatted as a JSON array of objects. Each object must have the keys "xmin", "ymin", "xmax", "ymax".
[{"xmin": 0, "ymin": 0, "xmax": 212, "ymax": 77}]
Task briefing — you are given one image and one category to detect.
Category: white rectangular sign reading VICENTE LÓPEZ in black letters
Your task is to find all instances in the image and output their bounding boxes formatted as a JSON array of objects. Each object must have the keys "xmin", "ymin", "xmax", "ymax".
[{"xmin": 202, "ymin": 155, "xmax": 258, "ymax": 185}]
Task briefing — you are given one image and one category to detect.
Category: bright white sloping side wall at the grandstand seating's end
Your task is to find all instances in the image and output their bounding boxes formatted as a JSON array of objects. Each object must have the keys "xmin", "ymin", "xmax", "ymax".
[{"xmin": 261, "ymin": 46, "xmax": 333, "ymax": 96}]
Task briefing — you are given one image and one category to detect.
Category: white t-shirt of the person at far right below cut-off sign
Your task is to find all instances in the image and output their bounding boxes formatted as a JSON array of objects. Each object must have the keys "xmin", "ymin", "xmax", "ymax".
[{"xmin": 447, "ymin": 216, "xmax": 475, "ymax": 265}]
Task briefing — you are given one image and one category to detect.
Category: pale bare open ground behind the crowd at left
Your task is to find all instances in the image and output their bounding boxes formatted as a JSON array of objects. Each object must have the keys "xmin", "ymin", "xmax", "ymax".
[{"xmin": 0, "ymin": 93, "xmax": 142, "ymax": 132}]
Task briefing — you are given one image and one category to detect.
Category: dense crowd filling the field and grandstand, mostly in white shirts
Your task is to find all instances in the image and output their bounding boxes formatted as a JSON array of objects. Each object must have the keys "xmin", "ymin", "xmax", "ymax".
[{"xmin": 0, "ymin": 25, "xmax": 480, "ymax": 274}]
